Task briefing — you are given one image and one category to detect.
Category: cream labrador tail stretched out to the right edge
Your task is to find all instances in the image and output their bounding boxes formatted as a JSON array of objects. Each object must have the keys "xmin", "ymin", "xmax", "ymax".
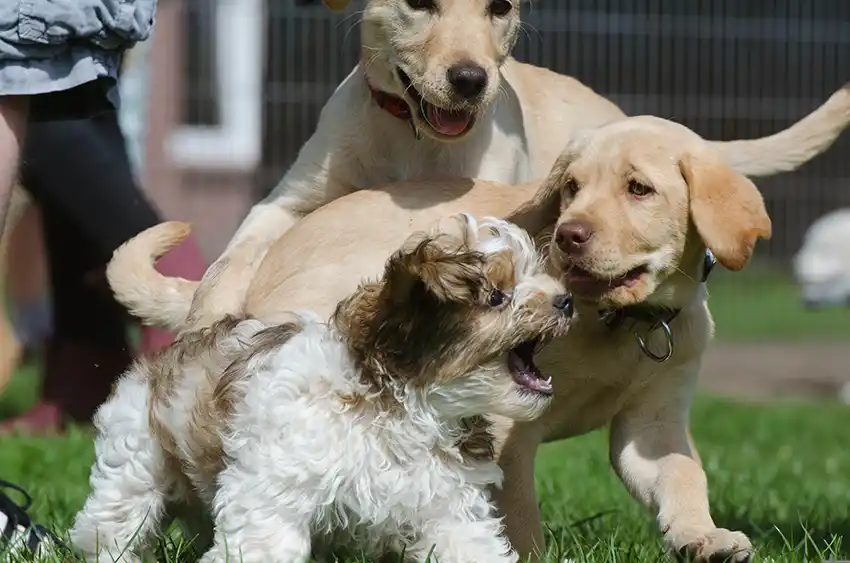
[{"xmin": 712, "ymin": 83, "xmax": 850, "ymax": 176}]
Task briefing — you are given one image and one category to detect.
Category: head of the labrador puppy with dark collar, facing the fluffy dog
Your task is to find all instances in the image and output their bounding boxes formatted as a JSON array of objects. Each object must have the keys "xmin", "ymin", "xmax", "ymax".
[{"xmin": 549, "ymin": 116, "xmax": 770, "ymax": 307}]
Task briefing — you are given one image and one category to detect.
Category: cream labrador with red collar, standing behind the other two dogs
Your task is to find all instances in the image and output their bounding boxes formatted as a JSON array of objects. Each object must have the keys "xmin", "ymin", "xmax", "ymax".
[{"xmin": 178, "ymin": 0, "xmax": 850, "ymax": 330}]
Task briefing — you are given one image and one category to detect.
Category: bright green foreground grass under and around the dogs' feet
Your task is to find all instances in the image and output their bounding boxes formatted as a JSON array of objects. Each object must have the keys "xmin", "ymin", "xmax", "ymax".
[{"xmin": 0, "ymin": 392, "xmax": 850, "ymax": 563}]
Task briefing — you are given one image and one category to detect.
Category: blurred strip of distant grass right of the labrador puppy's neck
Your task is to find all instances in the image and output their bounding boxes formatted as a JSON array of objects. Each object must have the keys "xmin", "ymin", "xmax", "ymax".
[{"xmin": 708, "ymin": 265, "xmax": 850, "ymax": 342}]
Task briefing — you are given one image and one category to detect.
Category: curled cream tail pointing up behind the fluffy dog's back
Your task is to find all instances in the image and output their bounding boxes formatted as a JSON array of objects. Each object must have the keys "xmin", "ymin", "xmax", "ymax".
[{"xmin": 106, "ymin": 221, "xmax": 199, "ymax": 331}]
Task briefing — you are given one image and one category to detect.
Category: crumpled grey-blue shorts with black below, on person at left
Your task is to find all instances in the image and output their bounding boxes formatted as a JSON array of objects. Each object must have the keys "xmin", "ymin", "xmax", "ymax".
[{"xmin": 0, "ymin": 0, "xmax": 157, "ymax": 119}]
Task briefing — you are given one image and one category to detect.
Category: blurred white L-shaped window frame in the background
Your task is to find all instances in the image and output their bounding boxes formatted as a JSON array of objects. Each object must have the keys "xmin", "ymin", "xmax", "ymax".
[{"xmin": 165, "ymin": 0, "xmax": 265, "ymax": 171}]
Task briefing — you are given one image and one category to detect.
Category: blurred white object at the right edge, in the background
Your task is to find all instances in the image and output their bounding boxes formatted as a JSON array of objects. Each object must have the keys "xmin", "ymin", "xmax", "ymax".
[{"xmin": 793, "ymin": 209, "xmax": 850, "ymax": 307}]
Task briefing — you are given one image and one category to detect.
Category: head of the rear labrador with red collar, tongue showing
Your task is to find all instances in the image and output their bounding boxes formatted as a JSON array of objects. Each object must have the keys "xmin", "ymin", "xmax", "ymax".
[{"xmin": 361, "ymin": 0, "xmax": 521, "ymax": 142}]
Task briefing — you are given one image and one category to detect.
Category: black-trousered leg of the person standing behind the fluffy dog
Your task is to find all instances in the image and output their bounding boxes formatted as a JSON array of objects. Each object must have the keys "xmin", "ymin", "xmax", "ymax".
[{"xmin": 21, "ymin": 112, "xmax": 159, "ymax": 421}]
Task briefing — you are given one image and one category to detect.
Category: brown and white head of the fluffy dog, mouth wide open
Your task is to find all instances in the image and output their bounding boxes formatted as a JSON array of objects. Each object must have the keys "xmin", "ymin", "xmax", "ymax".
[{"xmin": 333, "ymin": 216, "xmax": 571, "ymax": 424}]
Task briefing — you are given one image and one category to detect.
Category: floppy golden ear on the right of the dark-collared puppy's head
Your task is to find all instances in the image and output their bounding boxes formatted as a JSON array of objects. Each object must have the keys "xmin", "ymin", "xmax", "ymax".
[{"xmin": 679, "ymin": 153, "xmax": 771, "ymax": 271}]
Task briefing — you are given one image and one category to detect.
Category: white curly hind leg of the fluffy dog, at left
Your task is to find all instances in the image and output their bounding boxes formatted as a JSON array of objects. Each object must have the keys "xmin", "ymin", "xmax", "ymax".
[{"xmin": 69, "ymin": 368, "xmax": 171, "ymax": 563}]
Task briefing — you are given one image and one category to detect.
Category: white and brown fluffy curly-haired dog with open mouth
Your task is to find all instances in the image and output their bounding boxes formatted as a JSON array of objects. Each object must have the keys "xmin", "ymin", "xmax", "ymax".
[{"xmin": 71, "ymin": 215, "xmax": 572, "ymax": 563}]
